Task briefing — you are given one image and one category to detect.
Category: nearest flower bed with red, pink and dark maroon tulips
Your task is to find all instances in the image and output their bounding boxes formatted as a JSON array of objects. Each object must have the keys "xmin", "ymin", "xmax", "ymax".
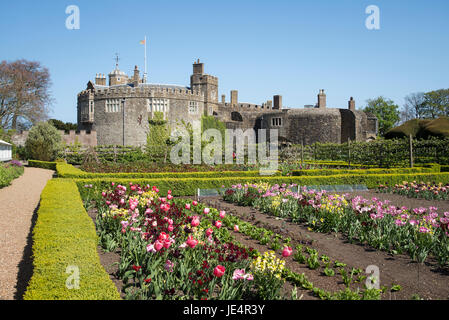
[{"xmin": 96, "ymin": 183, "xmax": 291, "ymax": 300}]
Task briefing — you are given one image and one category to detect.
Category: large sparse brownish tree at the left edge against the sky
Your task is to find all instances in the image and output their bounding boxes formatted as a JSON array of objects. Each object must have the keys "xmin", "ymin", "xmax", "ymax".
[{"xmin": 0, "ymin": 60, "xmax": 51, "ymax": 129}]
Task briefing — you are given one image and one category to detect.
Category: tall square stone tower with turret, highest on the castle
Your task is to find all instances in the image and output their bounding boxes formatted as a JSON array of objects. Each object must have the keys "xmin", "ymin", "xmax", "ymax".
[{"xmin": 190, "ymin": 59, "xmax": 218, "ymax": 115}]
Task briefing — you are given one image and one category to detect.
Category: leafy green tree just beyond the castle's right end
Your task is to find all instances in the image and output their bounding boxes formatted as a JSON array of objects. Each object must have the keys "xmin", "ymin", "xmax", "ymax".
[{"xmin": 363, "ymin": 96, "xmax": 399, "ymax": 136}]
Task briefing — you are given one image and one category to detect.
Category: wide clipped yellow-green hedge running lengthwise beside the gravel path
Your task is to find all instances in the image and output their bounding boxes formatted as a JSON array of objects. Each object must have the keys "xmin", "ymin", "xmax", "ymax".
[{"xmin": 24, "ymin": 179, "xmax": 120, "ymax": 300}]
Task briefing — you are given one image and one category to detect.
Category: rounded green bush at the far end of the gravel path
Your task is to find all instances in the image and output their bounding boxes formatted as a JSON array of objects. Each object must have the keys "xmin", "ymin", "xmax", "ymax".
[{"xmin": 25, "ymin": 122, "xmax": 62, "ymax": 161}]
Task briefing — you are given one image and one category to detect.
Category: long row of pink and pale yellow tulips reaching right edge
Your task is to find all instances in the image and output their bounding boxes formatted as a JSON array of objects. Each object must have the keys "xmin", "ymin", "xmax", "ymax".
[{"xmin": 223, "ymin": 184, "xmax": 449, "ymax": 266}]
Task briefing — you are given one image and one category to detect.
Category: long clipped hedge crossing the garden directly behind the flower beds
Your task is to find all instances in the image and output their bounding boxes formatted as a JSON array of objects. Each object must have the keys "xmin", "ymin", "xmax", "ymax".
[{"xmin": 75, "ymin": 173, "xmax": 449, "ymax": 197}]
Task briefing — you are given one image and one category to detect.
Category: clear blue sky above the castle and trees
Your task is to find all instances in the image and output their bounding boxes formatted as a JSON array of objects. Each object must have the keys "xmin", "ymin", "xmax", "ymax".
[{"xmin": 0, "ymin": 0, "xmax": 449, "ymax": 122}]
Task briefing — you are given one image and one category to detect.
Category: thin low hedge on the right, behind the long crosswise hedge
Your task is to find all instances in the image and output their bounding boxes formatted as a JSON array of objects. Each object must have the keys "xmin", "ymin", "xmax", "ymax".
[{"xmin": 292, "ymin": 167, "xmax": 440, "ymax": 176}]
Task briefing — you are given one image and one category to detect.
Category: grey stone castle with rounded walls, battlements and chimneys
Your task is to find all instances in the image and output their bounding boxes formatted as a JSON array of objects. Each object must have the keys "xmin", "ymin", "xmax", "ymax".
[{"xmin": 77, "ymin": 60, "xmax": 378, "ymax": 146}]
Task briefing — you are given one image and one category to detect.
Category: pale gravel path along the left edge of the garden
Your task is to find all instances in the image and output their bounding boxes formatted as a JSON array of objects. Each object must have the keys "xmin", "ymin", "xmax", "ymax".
[{"xmin": 0, "ymin": 168, "xmax": 53, "ymax": 300}]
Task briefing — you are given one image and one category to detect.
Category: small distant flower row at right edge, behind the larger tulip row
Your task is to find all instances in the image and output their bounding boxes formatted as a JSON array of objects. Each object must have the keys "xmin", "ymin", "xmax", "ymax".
[{"xmin": 377, "ymin": 181, "xmax": 449, "ymax": 200}]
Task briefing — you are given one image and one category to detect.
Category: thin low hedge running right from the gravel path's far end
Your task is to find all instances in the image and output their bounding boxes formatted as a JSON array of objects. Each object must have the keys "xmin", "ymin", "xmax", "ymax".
[{"xmin": 56, "ymin": 163, "xmax": 281, "ymax": 179}]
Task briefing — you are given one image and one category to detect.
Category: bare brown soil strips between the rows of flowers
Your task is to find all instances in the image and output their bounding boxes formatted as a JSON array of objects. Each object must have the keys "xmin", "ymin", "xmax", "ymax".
[{"xmin": 200, "ymin": 192, "xmax": 449, "ymax": 300}]
